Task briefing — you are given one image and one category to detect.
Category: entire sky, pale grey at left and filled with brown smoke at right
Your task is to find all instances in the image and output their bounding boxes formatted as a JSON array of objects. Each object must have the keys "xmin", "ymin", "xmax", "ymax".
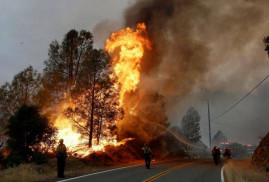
[{"xmin": 0, "ymin": 0, "xmax": 269, "ymax": 143}]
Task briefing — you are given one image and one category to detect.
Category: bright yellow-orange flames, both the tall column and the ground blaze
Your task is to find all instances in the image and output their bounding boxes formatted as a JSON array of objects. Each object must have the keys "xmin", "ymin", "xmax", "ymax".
[{"xmin": 51, "ymin": 23, "xmax": 150, "ymax": 156}]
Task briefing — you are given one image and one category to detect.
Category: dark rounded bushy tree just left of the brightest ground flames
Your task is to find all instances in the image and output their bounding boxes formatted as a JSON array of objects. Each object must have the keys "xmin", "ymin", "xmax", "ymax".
[{"xmin": 6, "ymin": 105, "xmax": 56, "ymax": 161}]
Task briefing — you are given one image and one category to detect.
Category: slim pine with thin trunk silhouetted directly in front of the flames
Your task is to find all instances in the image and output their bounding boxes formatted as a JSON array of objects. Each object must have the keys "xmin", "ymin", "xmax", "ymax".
[{"xmin": 66, "ymin": 50, "xmax": 120, "ymax": 147}]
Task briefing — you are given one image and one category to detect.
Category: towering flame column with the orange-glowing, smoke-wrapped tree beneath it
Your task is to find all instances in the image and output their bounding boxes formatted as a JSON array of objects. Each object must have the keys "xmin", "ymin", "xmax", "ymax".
[{"xmin": 105, "ymin": 23, "xmax": 168, "ymax": 140}]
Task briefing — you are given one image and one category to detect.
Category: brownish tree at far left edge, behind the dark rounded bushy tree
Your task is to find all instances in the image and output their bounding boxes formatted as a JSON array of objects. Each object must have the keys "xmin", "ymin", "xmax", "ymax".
[{"xmin": 0, "ymin": 66, "xmax": 42, "ymax": 141}]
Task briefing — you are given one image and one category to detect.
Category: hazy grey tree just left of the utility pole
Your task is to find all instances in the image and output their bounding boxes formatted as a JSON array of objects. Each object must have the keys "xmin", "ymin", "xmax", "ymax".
[{"xmin": 181, "ymin": 107, "xmax": 201, "ymax": 142}]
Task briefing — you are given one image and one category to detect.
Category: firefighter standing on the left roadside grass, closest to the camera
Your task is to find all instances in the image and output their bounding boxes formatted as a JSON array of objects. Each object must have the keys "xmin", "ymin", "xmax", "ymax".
[{"xmin": 56, "ymin": 139, "xmax": 66, "ymax": 178}]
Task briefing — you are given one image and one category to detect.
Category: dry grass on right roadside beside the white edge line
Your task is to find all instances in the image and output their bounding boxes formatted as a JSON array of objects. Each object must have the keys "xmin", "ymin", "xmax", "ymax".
[{"xmin": 224, "ymin": 160, "xmax": 269, "ymax": 182}]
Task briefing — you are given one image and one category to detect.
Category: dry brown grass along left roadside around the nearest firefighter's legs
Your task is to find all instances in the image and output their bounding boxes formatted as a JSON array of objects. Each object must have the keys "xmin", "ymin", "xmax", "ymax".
[{"xmin": 0, "ymin": 157, "xmax": 138, "ymax": 182}]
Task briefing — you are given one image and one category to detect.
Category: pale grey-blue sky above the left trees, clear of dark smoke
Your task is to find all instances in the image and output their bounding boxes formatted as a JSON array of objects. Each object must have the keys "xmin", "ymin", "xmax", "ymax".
[{"xmin": 0, "ymin": 0, "xmax": 131, "ymax": 85}]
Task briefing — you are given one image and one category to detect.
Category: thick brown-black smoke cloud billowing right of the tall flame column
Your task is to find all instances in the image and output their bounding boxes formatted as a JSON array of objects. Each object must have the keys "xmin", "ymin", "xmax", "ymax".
[{"xmin": 120, "ymin": 0, "xmax": 269, "ymax": 145}]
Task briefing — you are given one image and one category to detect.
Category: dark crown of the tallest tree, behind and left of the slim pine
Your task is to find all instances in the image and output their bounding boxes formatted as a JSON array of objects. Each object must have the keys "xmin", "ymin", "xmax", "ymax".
[{"xmin": 43, "ymin": 30, "xmax": 93, "ymax": 101}]
